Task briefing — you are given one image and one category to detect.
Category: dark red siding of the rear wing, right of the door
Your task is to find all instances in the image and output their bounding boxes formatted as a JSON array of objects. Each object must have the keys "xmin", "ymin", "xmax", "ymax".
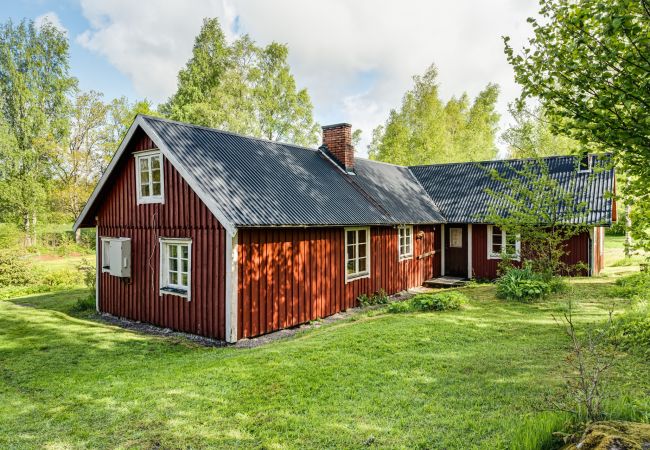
[{"xmin": 472, "ymin": 225, "xmax": 603, "ymax": 279}]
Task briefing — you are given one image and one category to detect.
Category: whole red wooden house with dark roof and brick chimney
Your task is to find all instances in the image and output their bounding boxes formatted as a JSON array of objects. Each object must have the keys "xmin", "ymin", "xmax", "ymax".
[{"xmin": 75, "ymin": 115, "xmax": 615, "ymax": 342}]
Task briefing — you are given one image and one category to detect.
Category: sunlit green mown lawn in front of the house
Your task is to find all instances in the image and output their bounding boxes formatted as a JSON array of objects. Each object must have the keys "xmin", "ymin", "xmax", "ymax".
[{"xmin": 0, "ymin": 239, "xmax": 650, "ymax": 449}]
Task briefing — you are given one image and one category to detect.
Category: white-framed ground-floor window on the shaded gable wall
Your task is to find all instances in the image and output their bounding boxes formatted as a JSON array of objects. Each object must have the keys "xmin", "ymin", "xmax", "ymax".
[{"xmin": 160, "ymin": 238, "xmax": 192, "ymax": 300}]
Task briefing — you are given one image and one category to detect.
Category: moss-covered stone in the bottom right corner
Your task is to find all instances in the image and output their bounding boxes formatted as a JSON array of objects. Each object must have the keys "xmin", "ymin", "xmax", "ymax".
[{"xmin": 563, "ymin": 421, "xmax": 650, "ymax": 450}]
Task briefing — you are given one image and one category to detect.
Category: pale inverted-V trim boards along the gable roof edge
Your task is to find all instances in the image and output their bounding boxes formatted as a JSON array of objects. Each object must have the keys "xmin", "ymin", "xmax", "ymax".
[{"xmin": 72, "ymin": 114, "xmax": 237, "ymax": 236}]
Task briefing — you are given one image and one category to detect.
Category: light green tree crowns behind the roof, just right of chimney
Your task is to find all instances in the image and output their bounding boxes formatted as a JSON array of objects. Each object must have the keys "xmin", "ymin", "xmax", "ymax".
[{"xmin": 368, "ymin": 65, "xmax": 499, "ymax": 165}]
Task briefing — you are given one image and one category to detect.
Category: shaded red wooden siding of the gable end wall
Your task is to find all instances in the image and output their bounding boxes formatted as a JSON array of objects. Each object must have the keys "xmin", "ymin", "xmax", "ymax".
[{"xmin": 97, "ymin": 128, "xmax": 226, "ymax": 339}]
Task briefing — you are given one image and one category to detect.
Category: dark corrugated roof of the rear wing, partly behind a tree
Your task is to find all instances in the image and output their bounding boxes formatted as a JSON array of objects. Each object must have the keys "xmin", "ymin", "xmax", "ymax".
[{"xmin": 410, "ymin": 155, "xmax": 614, "ymax": 225}]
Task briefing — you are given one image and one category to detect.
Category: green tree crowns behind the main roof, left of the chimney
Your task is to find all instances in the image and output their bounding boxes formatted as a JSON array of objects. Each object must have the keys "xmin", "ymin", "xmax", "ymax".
[{"xmin": 160, "ymin": 19, "xmax": 319, "ymax": 145}]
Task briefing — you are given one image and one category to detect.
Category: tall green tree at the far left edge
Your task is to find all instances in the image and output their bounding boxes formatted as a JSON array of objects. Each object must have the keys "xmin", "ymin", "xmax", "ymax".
[{"xmin": 0, "ymin": 20, "xmax": 76, "ymax": 244}]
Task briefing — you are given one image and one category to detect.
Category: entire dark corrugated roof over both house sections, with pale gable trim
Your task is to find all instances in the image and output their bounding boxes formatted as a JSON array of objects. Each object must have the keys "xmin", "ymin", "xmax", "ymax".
[{"xmin": 74, "ymin": 115, "xmax": 614, "ymax": 230}]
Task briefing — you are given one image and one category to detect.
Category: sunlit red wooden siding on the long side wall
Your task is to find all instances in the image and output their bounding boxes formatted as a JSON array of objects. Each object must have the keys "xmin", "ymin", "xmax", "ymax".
[{"xmin": 237, "ymin": 225, "xmax": 440, "ymax": 338}]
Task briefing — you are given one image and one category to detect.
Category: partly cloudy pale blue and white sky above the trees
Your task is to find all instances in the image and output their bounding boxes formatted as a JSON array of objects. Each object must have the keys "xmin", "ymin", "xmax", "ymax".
[{"xmin": 0, "ymin": 0, "xmax": 538, "ymax": 155}]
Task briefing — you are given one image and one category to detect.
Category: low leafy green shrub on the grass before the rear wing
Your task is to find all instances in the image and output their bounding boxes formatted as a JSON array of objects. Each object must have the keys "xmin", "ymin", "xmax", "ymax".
[{"xmin": 497, "ymin": 266, "xmax": 560, "ymax": 302}]
